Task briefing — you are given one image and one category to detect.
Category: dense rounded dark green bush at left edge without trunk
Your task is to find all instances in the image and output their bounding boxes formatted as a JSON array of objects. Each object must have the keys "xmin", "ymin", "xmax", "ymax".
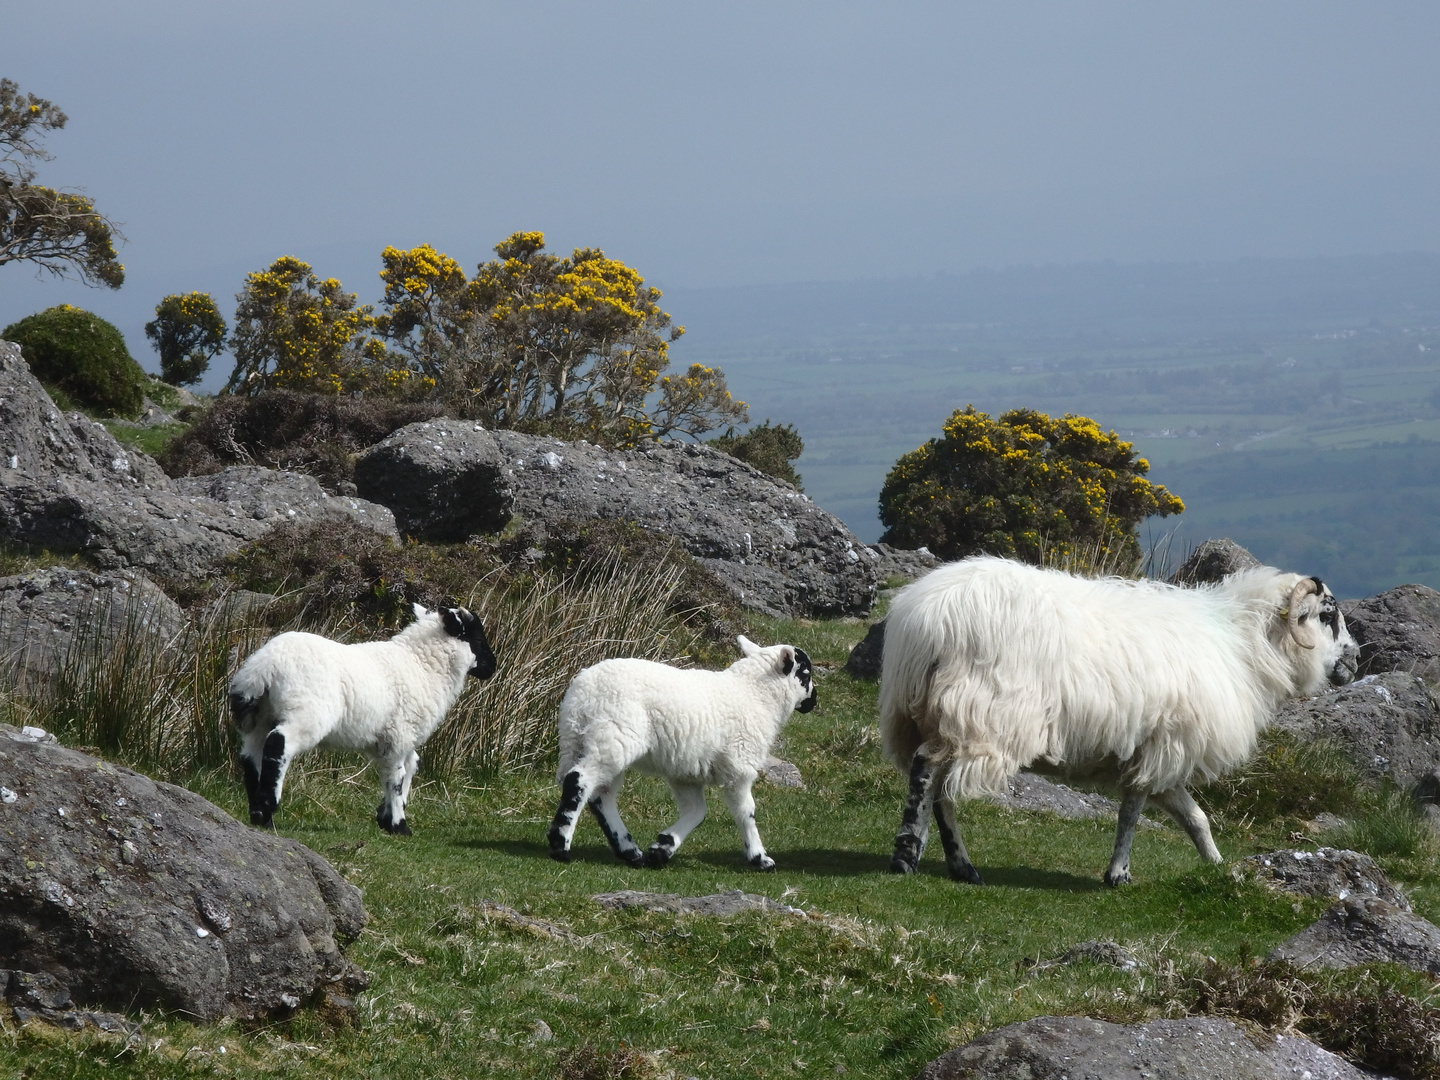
[{"xmin": 0, "ymin": 304, "xmax": 150, "ymax": 416}]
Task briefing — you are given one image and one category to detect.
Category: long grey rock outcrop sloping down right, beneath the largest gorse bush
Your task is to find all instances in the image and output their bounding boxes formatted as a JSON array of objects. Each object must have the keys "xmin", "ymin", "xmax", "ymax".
[{"xmin": 356, "ymin": 422, "xmax": 880, "ymax": 616}]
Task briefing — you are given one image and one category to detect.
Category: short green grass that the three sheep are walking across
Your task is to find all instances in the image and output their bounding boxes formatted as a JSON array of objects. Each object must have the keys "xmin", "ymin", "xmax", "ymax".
[{"xmin": 8, "ymin": 621, "xmax": 1440, "ymax": 1080}]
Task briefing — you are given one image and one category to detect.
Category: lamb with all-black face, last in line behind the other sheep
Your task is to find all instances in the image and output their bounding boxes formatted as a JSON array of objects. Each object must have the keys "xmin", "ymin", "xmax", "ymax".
[{"xmin": 230, "ymin": 603, "xmax": 495, "ymax": 837}]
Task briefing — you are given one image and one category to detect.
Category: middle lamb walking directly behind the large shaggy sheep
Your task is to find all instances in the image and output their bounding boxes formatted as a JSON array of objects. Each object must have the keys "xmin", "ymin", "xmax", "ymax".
[{"xmin": 549, "ymin": 635, "xmax": 815, "ymax": 870}]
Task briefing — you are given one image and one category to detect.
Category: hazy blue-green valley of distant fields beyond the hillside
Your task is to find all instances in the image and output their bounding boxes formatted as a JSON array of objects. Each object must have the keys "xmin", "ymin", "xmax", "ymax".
[{"xmin": 667, "ymin": 255, "xmax": 1440, "ymax": 595}]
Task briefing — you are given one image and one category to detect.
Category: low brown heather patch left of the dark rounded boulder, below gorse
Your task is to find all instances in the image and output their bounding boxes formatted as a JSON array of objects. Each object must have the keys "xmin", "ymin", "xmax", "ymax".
[{"xmin": 160, "ymin": 390, "xmax": 441, "ymax": 488}]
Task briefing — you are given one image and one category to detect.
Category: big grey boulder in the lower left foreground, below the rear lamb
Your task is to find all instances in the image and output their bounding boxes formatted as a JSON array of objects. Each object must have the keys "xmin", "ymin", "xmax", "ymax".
[{"xmin": 0, "ymin": 724, "xmax": 366, "ymax": 1020}]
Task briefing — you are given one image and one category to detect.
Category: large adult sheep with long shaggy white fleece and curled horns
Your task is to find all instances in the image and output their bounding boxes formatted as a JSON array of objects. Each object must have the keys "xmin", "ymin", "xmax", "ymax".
[{"xmin": 880, "ymin": 557, "xmax": 1359, "ymax": 886}]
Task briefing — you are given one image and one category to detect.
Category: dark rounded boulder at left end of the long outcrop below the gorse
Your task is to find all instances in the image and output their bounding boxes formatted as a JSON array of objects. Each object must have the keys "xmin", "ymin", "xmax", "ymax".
[{"xmin": 354, "ymin": 420, "xmax": 516, "ymax": 543}]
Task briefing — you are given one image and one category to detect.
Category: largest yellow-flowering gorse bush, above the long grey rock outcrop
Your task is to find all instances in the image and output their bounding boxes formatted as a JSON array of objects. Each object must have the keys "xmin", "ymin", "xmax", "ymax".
[{"xmin": 377, "ymin": 232, "xmax": 747, "ymax": 446}]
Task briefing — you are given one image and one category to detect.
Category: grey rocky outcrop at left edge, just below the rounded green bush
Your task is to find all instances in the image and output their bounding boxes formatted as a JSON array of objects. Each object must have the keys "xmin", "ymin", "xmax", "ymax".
[{"xmin": 0, "ymin": 341, "xmax": 395, "ymax": 577}]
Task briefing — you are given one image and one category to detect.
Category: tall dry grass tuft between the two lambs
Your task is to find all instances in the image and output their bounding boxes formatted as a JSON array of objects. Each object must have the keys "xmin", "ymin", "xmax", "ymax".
[{"xmin": 422, "ymin": 559, "xmax": 696, "ymax": 776}]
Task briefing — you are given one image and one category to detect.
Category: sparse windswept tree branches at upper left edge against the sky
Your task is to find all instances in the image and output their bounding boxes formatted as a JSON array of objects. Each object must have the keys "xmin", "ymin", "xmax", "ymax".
[{"xmin": 0, "ymin": 79, "xmax": 125, "ymax": 289}]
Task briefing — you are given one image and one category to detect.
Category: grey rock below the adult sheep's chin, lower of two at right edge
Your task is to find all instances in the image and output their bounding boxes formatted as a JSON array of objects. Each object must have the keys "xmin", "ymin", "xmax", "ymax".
[{"xmin": 1272, "ymin": 671, "xmax": 1440, "ymax": 789}]
